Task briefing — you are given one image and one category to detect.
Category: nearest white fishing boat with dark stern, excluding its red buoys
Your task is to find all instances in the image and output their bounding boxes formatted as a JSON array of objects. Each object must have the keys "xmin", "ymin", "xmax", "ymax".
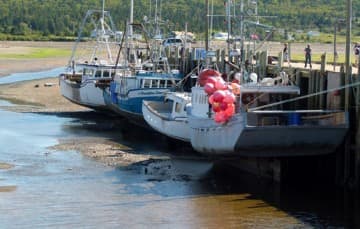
[{"xmin": 188, "ymin": 70, "xmax": 349, "ymax": 157}]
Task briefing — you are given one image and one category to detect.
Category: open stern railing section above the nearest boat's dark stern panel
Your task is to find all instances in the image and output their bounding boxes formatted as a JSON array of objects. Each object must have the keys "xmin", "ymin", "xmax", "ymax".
[{"xmin": 247, "ymin": 110, "xmax": 348, "ymax": 127}]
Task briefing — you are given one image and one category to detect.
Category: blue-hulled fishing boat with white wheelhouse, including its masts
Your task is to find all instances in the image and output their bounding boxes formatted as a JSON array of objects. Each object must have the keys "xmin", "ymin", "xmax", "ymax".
[{"xmin": 103, "ymin": 0, "xmax": 183, "ymax": 126}]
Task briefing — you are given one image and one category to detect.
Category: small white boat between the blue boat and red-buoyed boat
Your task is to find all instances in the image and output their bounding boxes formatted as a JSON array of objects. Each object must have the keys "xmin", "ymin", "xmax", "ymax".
[{"xmin": 142, "ymin": 92, "xmax": 191, "ymax": 142}]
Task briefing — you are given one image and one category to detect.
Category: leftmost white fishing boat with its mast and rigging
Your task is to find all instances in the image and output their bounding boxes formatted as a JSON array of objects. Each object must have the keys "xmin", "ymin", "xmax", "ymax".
[{"xmin": 59, "ymin": 1, "xmax": 124, "ymax": 110}]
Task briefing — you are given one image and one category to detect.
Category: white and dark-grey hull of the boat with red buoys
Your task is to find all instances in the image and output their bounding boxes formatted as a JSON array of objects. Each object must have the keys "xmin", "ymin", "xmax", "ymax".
[{"xmin": 189, "ymin": 114, "xmax": 348, "ymax": 157}]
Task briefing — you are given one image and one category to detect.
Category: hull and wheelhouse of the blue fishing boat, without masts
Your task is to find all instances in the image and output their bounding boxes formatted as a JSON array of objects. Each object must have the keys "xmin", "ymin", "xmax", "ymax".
[{"xmin": 103, "ymin": 44, "xmax": 183, "ymax": 123}]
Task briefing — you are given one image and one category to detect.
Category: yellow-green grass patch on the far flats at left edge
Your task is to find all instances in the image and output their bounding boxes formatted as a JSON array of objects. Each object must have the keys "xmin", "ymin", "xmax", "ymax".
[{"xmin": 0, "ymin": 48, "xmax": 71, "ymax": 59}]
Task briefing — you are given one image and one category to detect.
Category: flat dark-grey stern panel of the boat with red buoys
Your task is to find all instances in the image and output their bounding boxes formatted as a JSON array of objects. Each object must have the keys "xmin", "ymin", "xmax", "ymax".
[{"xmin": 234, "ymin": 125, "xmax": 347, "ymax": 157}]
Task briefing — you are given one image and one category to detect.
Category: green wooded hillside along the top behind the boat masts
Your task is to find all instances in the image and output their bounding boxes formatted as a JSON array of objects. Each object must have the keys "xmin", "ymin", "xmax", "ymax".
[{"xmin": 0, "ymin": 0, "xmax": 360, "ymax": 39}]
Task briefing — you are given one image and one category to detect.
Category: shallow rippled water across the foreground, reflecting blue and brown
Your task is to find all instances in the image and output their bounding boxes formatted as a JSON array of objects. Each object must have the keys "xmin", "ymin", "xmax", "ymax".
[{"xmin": 0, "ymin": 70, "xmax": 360, "ymax": 228}]
